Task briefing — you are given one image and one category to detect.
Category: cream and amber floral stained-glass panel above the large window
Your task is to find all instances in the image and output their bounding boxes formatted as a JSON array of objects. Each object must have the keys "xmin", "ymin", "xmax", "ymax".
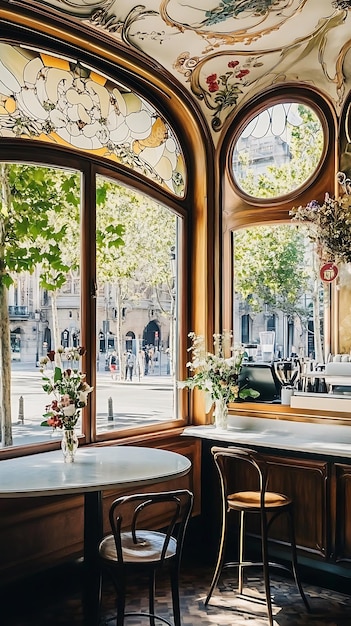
[{"xmin": 0, "ymin": 44, "xmax": 185, "ymax": 196}]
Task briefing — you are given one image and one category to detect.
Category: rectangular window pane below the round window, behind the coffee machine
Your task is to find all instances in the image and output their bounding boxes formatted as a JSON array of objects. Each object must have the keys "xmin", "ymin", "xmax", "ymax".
[{"xmin": 233, "ymin": 224, "xmax": 329, "ymax": 390}]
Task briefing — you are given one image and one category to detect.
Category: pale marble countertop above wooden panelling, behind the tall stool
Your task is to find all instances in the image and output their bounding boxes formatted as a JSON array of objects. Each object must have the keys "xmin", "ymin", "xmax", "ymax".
[{"xmin": 183, "ymin": 416, "xmax": 351, "ymax": 459}]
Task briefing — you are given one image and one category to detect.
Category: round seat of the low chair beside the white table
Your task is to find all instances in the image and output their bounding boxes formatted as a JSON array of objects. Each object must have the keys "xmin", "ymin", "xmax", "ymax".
[{"xmin": 99, "ymin": 530, "xmax": 177, "ymax": 563}]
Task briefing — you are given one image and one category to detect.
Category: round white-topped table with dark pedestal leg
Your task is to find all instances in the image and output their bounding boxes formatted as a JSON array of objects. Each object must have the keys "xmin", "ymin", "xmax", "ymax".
[{"xmin": 0, "ymin": 446, "xmax": 191, "ymax": 626}]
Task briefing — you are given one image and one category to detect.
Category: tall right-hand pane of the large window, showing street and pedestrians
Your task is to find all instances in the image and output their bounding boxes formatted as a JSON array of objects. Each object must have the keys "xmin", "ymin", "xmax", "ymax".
[{"xmin": 96, "ymin": 177, "xmax": 177, "ymax": 434}]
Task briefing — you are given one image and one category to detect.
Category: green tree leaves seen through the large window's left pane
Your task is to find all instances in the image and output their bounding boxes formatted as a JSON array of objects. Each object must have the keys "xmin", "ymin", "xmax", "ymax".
[{"xmin": 0, "ymin": 164, "xmax": 80, "ymax": 289}]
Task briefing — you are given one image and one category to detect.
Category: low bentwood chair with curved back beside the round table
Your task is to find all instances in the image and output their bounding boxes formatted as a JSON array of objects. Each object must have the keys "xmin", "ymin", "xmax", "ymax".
[{"xmin": 99, "ymin": 489, "xmax": 193, "ymax": 626}]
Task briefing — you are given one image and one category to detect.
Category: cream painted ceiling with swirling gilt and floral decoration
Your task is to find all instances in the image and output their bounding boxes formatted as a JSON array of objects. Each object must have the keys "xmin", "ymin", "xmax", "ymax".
[{"xmin": 4, "ymin": 0, "xmax": 351, "ymax": 143}]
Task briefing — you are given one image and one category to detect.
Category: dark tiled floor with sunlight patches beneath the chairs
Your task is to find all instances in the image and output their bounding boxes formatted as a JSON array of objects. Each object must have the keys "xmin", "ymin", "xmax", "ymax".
[{"xmin": 0, "ymin": 563, "xmax": 351, "ymax": 626}]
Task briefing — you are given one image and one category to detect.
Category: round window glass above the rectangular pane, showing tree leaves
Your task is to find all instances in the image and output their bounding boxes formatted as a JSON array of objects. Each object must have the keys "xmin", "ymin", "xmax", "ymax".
[{"xmin": 232, "ymin": 102, "xmax": 324, "ymax": 198}]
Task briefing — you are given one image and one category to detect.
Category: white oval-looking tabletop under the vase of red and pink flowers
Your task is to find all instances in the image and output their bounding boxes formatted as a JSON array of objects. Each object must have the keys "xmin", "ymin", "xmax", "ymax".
[{"xmin": 0, "ymin": 446, "xmax": 191, "ymax": 498}]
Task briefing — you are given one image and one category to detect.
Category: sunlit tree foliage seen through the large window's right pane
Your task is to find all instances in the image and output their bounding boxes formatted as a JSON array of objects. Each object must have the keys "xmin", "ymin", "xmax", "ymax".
[{"xmin": 96, "ymin": 178, "xmax": 176, "ymax": 299}]
